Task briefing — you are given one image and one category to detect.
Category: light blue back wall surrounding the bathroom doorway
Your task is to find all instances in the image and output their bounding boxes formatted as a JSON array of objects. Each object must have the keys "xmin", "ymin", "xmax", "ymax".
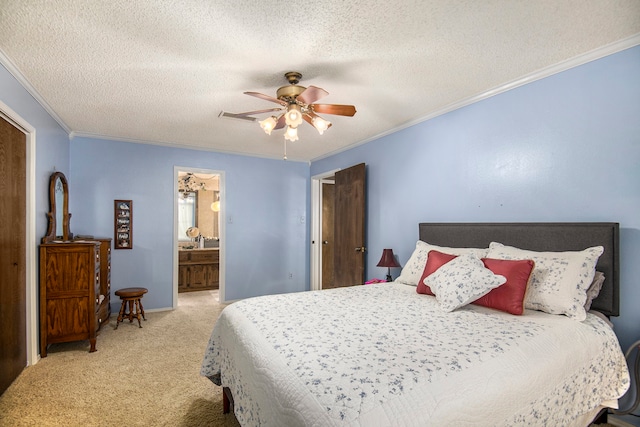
[{"xmin": 70, "ymin": 138, "xmax": 310, "ymax": 308}]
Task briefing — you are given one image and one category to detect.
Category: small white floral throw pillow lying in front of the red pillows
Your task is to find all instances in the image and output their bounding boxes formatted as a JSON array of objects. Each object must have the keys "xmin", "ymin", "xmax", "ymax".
[{"xmin": 424, "ymin": 254, "xmax": 507, "ymax": 312}]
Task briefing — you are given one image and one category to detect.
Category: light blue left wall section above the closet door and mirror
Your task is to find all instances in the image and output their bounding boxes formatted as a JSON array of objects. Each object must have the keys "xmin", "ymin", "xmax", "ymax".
[{"xmin": 0, "ymin": 65, "xmax": 69, "ymax": 243}]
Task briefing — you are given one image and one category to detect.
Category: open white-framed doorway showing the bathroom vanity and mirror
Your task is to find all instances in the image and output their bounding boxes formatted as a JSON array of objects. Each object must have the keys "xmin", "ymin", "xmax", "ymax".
[{"xmin": 173, "ymin": 166, "xmax": 225, "ymax": 308}]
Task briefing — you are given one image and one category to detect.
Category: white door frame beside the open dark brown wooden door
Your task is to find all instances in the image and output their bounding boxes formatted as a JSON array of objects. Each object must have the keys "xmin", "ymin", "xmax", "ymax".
[{"xmin": 310, "ymin": 169, "xmax": 341, "ymax": 291}]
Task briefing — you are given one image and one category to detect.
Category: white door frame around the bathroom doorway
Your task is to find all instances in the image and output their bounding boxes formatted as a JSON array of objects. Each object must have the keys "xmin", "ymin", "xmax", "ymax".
[{"xmin": 173, "ymin": 166, "xmax": 227, "ymax": 309}]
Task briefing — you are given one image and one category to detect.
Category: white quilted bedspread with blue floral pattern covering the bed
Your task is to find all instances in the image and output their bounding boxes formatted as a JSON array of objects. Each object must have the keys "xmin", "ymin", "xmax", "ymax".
[{"xmin": 201, "ymin": 283, "xmax": 629, "ymax": 427}]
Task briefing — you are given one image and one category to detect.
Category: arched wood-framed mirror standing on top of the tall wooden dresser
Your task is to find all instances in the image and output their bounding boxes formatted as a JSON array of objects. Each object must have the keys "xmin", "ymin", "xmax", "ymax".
[{"xmin": 42, "ymin": 172, "xmax": 73, "ymax": 243}]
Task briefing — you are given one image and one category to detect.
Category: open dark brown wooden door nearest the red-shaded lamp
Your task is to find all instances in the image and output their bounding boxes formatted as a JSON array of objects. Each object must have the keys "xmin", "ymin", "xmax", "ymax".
[{"xmin": 333, "ymin": 163, "xmax": 366, "ymax": 287}]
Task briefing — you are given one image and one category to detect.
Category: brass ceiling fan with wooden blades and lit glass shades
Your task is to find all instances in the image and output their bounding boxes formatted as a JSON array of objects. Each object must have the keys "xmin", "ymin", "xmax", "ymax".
[{"xmin": 220, "ymin": 71, "xmax": 356, "ymax": 141}]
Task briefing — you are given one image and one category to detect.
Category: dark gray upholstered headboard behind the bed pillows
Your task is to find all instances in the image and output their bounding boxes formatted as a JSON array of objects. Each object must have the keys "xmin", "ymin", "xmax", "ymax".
[{"xmin": 419, "ymin": 222, "xmax": 620, "ymax": 316}]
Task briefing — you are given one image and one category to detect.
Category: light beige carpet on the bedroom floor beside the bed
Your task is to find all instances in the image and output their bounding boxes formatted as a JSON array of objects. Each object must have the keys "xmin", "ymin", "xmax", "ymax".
[{"xmin": 0, "ymin": 291, "xmax": 239, "ymax": 427}]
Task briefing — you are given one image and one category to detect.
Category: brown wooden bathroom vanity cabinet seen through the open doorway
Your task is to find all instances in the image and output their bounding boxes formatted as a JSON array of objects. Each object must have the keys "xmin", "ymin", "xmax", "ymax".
[{"xmin": 178, "ymin": 249, "xmax": 220, "ymax": 292}]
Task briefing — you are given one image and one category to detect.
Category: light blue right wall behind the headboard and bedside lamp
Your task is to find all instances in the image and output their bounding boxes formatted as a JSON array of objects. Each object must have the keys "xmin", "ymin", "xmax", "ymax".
[{"xmin": 311, "ymin": 47, "xmax": 640, "ymax": 348}]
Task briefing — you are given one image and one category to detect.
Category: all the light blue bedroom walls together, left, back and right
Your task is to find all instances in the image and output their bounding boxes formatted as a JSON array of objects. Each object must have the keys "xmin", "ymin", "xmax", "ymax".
[{"xmin": 0, "ymin": 43, "xmax": 640, "ymax": 356}]
